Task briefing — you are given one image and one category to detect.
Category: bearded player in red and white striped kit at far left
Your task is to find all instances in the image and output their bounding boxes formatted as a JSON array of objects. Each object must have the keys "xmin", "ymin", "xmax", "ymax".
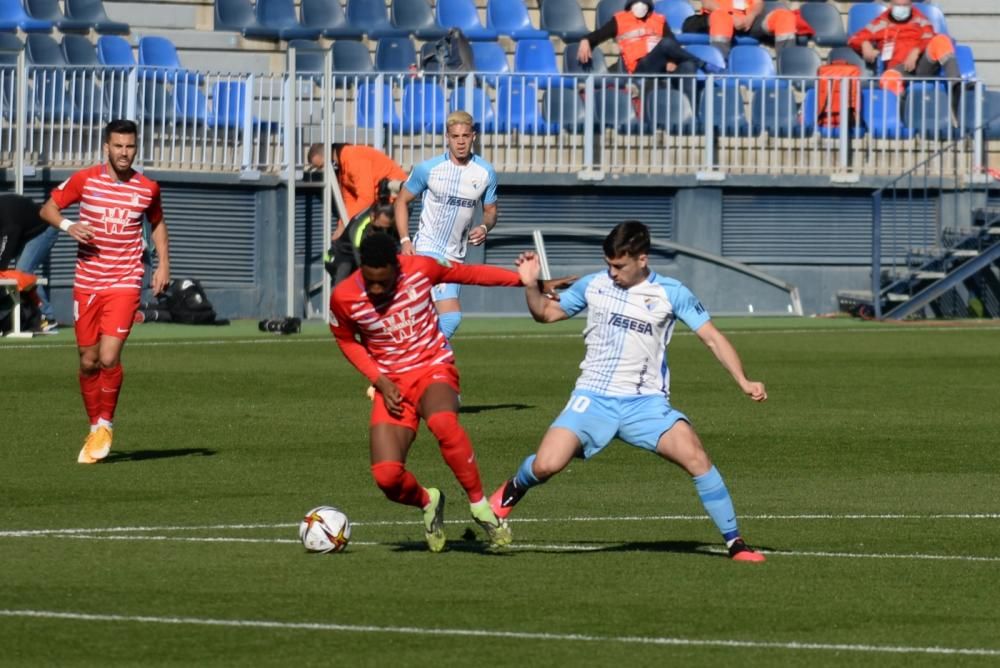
[{"xmin": 41, "ymin": 120, "xmax": 170, "ymax": 464}]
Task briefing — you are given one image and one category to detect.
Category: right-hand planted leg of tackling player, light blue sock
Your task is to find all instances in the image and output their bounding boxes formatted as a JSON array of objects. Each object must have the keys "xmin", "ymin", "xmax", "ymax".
[{"xmin": 656, "ymin": 420, "xmax": 765, "ymax": 561}]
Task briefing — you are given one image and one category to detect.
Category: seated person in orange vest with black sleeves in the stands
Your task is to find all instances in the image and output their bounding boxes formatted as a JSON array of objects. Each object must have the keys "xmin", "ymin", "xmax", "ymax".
[{"xmin": 576, "ymin": 0, "xmax": 706, "ymax": 74}]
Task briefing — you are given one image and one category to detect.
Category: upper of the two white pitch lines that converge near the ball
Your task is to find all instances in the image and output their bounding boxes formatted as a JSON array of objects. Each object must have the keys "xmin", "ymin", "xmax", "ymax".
[{"xmin": 0, "ymin": 513, "xmax": 1000, "ymax": 538}]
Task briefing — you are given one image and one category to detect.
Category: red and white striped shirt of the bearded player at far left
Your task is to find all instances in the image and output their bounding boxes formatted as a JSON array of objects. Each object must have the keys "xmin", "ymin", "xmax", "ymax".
[{"xmin": 52, "ymin": 165, "xmax": 163, "ymax": 292}]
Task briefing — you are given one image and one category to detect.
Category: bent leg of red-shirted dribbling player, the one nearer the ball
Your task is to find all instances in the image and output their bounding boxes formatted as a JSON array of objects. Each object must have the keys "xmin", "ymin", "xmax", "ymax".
[{"xmin": 370, "ymin": 422, "xmax": 447, "ymax": 552}]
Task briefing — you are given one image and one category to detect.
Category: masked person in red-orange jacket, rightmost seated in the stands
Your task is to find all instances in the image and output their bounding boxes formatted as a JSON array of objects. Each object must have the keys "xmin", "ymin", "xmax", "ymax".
[{"xmin": 847, "ymin": 0, "xmax": 962, "ymax": 95}]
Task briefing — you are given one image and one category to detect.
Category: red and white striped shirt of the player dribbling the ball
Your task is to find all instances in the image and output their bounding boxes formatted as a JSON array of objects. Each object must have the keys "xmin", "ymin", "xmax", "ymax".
[{"xmin": 330, "ymin": 255, "xmax": 521, "ymax": 382}]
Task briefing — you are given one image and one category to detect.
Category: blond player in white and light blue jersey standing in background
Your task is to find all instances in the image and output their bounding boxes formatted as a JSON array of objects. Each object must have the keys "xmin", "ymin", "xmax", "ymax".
[{"xmin": 396, "ymin": 111, "xmax": 497, "ymax": 339}]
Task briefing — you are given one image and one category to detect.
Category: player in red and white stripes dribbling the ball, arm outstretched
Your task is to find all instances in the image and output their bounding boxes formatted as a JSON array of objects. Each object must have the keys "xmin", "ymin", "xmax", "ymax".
[{"xmin": 330, "ymin": 234, "xmax": 521, "ymax": 552}]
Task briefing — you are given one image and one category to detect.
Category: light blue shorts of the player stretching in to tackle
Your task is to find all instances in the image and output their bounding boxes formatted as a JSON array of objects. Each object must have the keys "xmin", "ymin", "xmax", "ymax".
[{"xmin": 552, "ymin": 390, "xmax": 690, "ymax": 459}]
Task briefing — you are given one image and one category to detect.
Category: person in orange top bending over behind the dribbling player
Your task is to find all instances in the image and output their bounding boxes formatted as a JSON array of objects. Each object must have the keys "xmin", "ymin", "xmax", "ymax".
[{"xmin": 308, "ymin": 143, "xmax": 406, "ymax": 239}]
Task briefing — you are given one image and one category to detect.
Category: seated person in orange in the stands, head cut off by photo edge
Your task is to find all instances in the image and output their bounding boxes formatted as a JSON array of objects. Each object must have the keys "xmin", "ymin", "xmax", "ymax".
[{"xmin": 682, "ymin": 0, "xmax": 795, "ymax": 60}]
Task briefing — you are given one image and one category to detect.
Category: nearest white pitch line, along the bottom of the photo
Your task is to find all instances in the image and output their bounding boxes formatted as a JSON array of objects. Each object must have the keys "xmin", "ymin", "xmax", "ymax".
[{"xmin": 0, "ymin": 609, "xmax": 1000, "ymax": 657}]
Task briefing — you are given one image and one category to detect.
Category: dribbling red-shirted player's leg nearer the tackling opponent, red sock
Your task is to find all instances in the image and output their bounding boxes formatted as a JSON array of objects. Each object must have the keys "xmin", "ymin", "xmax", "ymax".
[{"xmin": 420, "ymin": 376, "xmax": 513, "ymax": 547}]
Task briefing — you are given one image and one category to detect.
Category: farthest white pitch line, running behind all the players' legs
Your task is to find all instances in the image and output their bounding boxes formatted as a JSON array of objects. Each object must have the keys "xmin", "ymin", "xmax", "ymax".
[{"xmin": 0, "ymin": 325, "xmax": 1000, "ymax": 351}]
